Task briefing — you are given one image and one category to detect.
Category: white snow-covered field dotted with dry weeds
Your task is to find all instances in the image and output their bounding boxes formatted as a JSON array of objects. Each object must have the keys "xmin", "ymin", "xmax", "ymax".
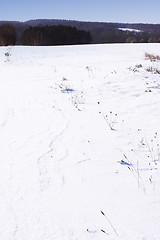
[{"xmin": 0, "ymin": 44, "xmax": 160, "ymax": 240}]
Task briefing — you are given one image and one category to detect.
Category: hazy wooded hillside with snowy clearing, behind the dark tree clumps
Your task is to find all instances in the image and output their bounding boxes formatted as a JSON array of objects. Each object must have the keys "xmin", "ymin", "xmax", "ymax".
[{"xmin": 0, "ymin": 19, "xmax": 160, "ymax": 43}]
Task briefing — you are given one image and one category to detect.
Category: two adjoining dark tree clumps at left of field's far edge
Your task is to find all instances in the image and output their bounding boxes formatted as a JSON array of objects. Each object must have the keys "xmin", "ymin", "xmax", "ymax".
[{"xmin": 0, "ymin": 24, "xmax": 92, "ymax": 46}]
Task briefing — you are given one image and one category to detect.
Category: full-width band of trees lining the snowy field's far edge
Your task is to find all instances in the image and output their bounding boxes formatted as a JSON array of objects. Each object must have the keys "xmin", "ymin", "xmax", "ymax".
[{"xmin": 0, "ymin": 23, "xmax": 160, "ymax": 46}]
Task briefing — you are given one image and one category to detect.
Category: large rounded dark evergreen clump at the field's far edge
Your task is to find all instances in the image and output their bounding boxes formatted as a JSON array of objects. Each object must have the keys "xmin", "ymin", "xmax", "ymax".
[{"xmin": 20, "ymin": 25, "xmax": 92, "ymax": 46}]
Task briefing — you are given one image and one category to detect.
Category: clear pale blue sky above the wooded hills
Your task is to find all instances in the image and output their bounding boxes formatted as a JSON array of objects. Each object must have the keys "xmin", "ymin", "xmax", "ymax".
[{"xmin": 0, "ymin": 0, "xmax": 160, "ymax": 23}]
